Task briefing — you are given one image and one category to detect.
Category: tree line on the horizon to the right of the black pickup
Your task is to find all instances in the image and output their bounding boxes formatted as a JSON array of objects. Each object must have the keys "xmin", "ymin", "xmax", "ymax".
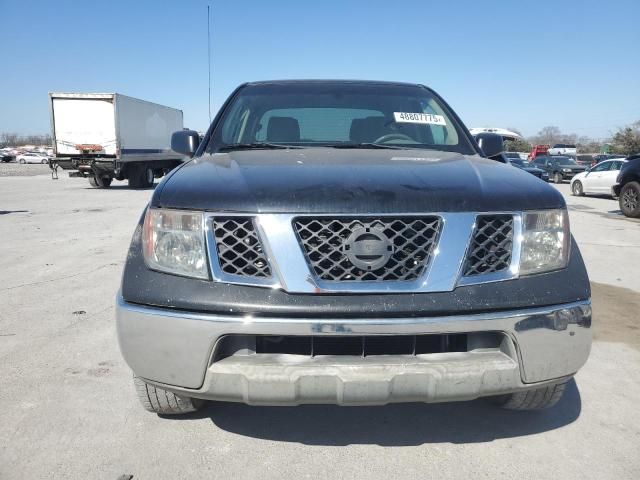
[{"xmin": 506, "ymin": 120, "xmax": 640, "ymax": 155}]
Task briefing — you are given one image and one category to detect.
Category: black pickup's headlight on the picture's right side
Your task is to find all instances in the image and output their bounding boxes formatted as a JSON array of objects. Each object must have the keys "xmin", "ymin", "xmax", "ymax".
[{"xmin": 520, "ymin": 210, "xmax": 571, "ymax": 275}]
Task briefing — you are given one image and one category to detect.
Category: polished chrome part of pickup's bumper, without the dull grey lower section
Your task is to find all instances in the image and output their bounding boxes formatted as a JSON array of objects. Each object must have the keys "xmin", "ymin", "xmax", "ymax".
[{"xmin": 116, "ymin": 296, "xmax": 591, "ymax": 403}]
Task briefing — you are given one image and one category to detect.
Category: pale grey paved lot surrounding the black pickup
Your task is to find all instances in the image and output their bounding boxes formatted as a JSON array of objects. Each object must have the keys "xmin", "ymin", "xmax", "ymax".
[{"xmin": 0, "ymin": 172, "xmax": 640, "ymax": 480}]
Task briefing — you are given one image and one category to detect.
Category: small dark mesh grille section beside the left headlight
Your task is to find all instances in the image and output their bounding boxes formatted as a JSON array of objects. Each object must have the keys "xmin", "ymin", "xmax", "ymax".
[{"xmin": 212, "ymin": 217, "xmax": 271, "ymax": 278}]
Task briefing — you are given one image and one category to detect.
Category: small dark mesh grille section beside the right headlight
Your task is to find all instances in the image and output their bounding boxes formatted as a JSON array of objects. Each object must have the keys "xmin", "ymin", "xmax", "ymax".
[{"xmin": 464, "ymin": 215, "xmax": 513, "ymax": 277}]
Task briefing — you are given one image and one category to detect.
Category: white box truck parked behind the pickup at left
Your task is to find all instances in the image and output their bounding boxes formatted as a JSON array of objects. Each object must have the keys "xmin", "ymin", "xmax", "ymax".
[{"xmin": 49, "ymin": 93, "xmax": 183, "ymax": 188}]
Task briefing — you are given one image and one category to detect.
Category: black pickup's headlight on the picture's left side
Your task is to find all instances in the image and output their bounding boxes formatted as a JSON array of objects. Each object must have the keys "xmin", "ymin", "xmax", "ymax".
[{"xmin": 142, "ymin": 208, "xmax": 209, "ymax": 279}]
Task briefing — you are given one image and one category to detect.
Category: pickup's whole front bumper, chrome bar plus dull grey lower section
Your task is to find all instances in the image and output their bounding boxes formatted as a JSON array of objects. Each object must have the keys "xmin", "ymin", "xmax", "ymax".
[{"xmin": 116, "ymin": 296, "xmax": 591, "ymax": 405}]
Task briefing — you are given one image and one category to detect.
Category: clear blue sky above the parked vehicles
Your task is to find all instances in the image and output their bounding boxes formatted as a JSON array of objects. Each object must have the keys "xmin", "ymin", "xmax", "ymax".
[{"xmin": 0, "ymin": 0, "xmax": 640, "ymax": 137}]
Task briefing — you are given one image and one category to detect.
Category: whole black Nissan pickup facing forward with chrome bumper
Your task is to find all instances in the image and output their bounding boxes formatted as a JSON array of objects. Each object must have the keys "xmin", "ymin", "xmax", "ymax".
[{"xmin": 116, "ymin": 80, "xmax": 591, "ymax": 414}]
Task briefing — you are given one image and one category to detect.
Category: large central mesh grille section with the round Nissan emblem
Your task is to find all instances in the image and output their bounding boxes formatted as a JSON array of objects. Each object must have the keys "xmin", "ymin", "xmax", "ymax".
[{"xmin": 293, "ymin": 216, "xmax": 441, "ymax": 282}]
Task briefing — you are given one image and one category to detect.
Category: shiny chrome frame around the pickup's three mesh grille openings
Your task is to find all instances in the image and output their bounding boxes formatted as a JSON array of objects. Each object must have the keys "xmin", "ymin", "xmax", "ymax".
[{"xmin": 205, "ymin": 212, "xmax": 522, "ymax": 294}]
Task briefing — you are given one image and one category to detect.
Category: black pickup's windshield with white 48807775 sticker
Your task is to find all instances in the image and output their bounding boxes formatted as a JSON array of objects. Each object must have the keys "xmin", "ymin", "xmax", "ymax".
[{"xmin": 207, "ymin": 82, "xmax": 476, "ymax": 155}]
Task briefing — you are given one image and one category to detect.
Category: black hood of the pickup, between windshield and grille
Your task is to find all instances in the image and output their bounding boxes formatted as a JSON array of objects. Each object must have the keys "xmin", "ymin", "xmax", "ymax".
[{"xmin": 151, "ymin": 148, "xmax": 565, "ymax": 214}]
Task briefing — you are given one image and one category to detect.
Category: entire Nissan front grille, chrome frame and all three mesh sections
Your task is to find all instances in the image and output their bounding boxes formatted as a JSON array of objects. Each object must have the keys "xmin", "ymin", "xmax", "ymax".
[{"xmin": 205, "ymin": 212, "xmax": 522, "ymax": 295}]
